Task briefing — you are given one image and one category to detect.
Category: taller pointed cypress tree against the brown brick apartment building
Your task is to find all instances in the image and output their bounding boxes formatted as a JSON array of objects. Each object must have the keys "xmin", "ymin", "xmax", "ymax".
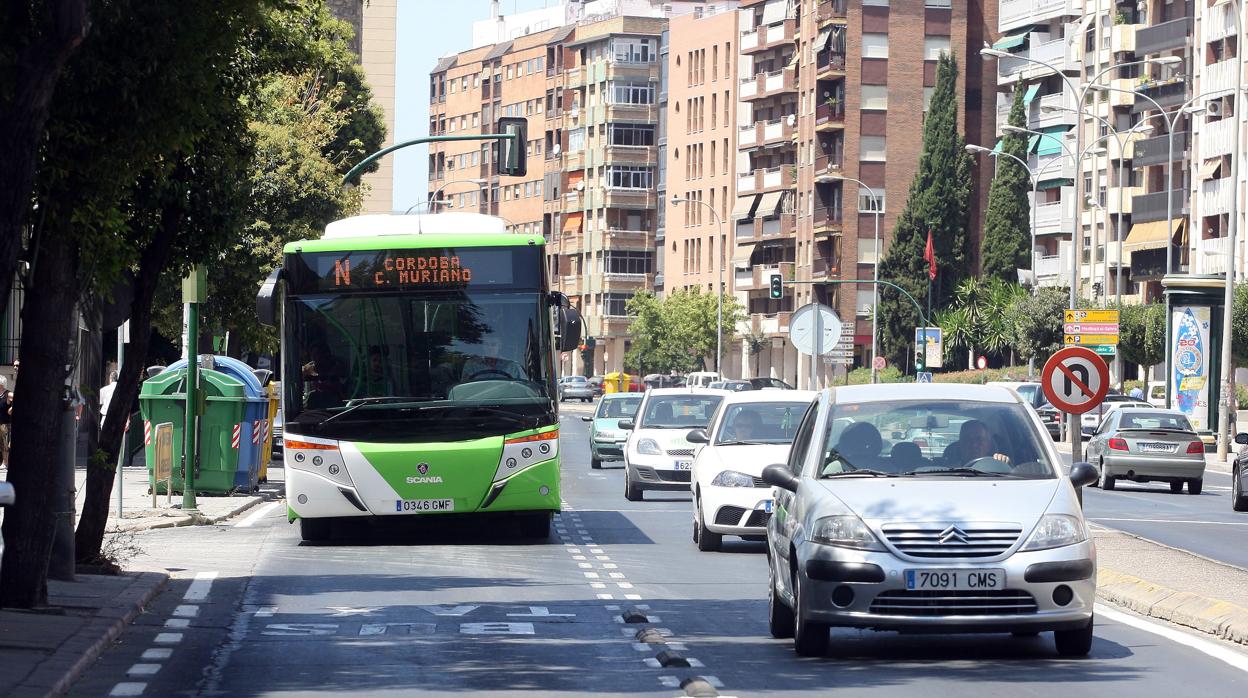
[{"xmin": 880, "ymin": 54, "xmax": 971, "ymax": 366}]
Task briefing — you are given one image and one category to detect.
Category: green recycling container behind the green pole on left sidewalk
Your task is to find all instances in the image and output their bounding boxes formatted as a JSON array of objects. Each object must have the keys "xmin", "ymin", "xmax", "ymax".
[{"xmin": 139, "ymin": 367, "xmax": 248, "ymax": 494}]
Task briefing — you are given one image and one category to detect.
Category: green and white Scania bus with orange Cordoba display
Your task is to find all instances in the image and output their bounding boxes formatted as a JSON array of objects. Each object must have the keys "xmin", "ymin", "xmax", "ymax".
[{"xmin": 257, "ymin": 214, "xmax": 580, "ymax": 541}]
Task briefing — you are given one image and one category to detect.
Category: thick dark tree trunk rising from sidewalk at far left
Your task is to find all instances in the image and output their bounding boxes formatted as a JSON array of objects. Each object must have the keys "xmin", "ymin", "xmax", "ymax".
[{"xmin": 0, "ymin": 231, "xmax": 79, "ymax": 608}]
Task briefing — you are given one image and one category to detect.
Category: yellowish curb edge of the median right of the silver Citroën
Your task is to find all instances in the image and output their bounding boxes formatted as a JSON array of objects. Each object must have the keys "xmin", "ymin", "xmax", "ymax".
[{"xmin": 1096, "ymin": 567, "xmax": 1248, "ymax": 646}]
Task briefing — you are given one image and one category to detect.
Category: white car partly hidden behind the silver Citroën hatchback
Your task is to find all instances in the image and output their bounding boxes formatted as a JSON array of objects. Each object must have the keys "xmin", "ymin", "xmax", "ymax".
[{"xmin": 685, "ymin": 390, "xmax": 816, "ymax": 551}]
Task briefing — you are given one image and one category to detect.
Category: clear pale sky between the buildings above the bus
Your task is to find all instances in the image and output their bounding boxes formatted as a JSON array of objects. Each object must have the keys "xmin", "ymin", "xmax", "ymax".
[{"xmin": 391, "ymin": 0, "xmax": 546, "ymax": 211}]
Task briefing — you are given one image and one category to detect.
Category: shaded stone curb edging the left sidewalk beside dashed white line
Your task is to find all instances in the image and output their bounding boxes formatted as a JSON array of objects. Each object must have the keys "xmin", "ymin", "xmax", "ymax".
[{"xmin": 16, "ymin": 572, "xmax": 168, "ymax": 696}]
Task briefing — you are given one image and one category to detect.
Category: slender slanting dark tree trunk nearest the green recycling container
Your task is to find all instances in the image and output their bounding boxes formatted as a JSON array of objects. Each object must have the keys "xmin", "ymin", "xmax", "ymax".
[{"xmin": 75, "ymin": 227, "xmax": 177, "ymax": 563}]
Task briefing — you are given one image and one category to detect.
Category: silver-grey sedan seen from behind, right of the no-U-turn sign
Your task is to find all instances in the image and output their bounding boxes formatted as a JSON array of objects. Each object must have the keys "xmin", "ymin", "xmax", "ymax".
[{"xmin": 1085, "ymin": 405, "xmax": 1204, "ymax": 494}]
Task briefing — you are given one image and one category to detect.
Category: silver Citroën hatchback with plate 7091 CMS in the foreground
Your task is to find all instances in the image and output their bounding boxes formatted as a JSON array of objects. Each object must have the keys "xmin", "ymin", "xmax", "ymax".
[{"xmin": 763, "ymin": 383, "xmax": 1096, "ymax": 656}]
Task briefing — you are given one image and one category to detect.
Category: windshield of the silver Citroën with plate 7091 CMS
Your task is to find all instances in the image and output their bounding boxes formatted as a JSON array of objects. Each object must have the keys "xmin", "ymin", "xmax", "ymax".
[{"xmin": 820, "ymin": 400, "xmax": 1056, "ymax": 479}]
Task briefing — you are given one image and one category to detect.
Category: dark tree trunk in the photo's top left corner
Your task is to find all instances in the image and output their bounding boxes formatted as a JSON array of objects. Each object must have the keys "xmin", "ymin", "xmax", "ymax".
[{"xmin": 0, "ymin": 0, "xmax": 89, "ymax": 315}]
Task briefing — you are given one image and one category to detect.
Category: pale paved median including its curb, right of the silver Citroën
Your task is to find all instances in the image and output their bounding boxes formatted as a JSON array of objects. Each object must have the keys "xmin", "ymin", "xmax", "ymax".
[{"xmin": 1093, "ymin": 527, "xmax": 1248, "ymax": 644}]
